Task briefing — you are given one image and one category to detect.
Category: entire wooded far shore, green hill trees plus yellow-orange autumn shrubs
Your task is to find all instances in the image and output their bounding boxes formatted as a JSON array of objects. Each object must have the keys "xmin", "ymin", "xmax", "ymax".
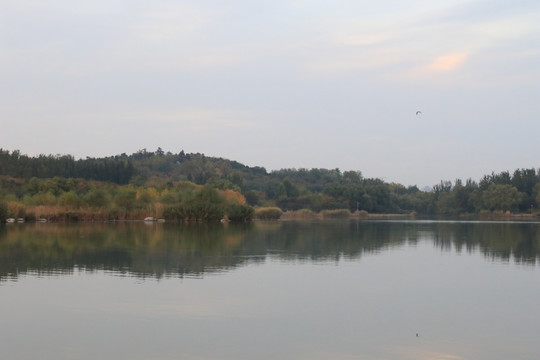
[{"xmin": 0, "ymin": 148, "xmax": 540, "ymax": 221}]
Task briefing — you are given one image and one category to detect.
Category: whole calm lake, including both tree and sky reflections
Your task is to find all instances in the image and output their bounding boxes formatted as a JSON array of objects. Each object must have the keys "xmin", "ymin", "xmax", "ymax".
[{"xmin": 0, "ymin": 221, "xmax": 540, "ymax": 360}]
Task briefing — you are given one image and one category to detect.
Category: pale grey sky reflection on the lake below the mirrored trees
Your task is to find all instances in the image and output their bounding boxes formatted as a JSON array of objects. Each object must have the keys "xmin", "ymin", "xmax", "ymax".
[{"xmin": 0, "ymin": 242, "xmax": 540, "ymax": 360}]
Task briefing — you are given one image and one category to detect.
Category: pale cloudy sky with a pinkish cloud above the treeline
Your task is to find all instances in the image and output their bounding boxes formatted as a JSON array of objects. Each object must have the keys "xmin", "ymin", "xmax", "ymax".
[{"xmin": 0, "ymin": 0, "xmax": 540, "ymax": 187}]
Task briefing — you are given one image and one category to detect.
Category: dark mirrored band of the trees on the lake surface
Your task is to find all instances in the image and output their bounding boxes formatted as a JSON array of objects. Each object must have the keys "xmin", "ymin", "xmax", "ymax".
[{"xmin": 0, "ymin": 221, "xmax": 540, "ymax": 280}]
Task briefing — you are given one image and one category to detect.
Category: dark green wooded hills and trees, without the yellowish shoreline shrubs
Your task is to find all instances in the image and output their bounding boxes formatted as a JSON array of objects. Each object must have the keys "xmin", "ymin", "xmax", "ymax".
[{"xmin": 0, "ymin": 148, "xmax": 540, "ymax": 214}]
